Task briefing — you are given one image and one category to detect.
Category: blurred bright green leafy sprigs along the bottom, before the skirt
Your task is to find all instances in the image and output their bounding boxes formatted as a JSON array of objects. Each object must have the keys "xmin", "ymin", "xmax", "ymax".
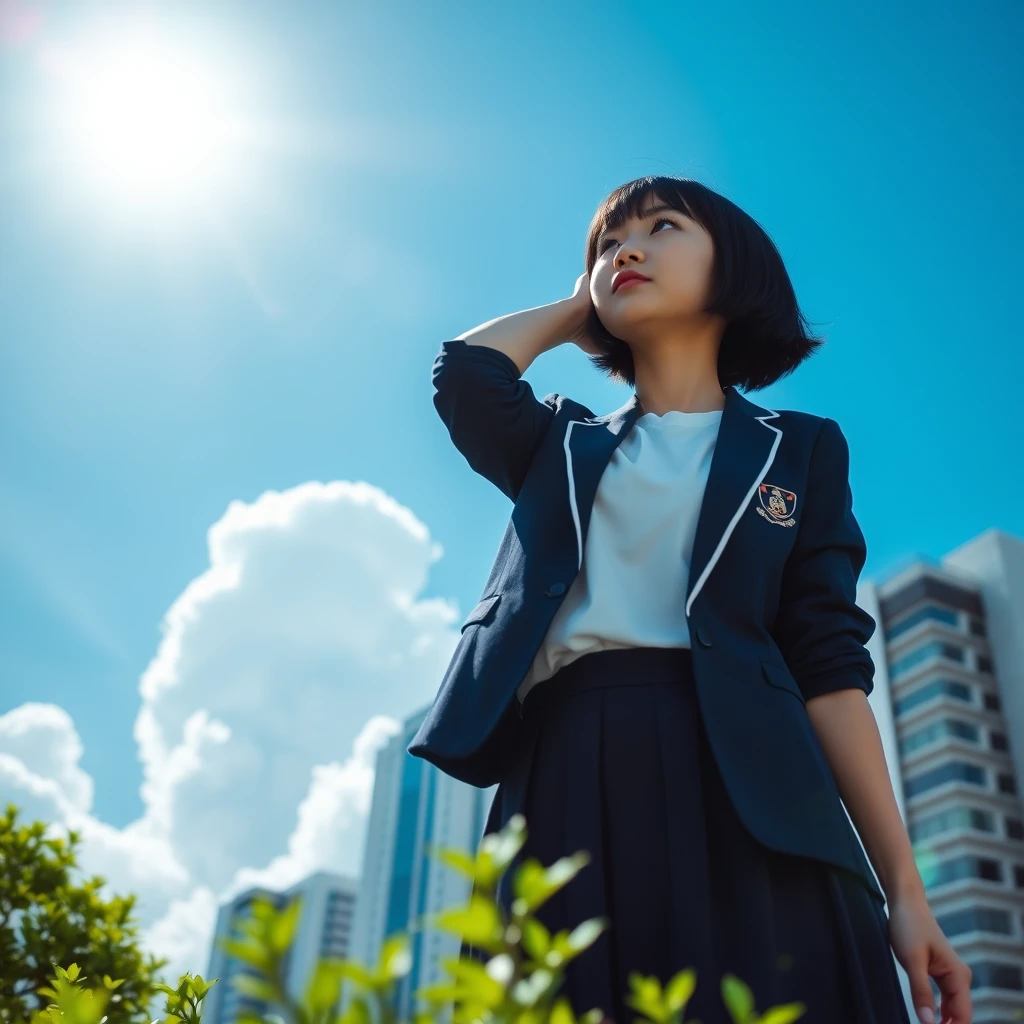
[{"xmin": 9, "ymin": 815, "xmax": 805, "ymax": 1024}]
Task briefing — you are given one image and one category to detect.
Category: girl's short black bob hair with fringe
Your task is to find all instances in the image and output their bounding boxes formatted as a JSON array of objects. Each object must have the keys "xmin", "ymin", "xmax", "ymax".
[{"xmin": 585, "ymin": 175, "xmax": 824, "ymax": 391}]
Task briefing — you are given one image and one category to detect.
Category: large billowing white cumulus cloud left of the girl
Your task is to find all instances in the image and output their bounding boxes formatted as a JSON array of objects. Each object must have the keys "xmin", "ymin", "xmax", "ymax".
[{"xmin": 0, "ymin": 481, "xmax": 459, "ymax": 979}]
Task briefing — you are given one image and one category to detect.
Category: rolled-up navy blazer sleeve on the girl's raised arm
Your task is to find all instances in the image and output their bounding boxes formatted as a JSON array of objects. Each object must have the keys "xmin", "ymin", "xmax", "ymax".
[{"xmin": 432, "ymin": 338, "xmax": 558, "ymax": 502}]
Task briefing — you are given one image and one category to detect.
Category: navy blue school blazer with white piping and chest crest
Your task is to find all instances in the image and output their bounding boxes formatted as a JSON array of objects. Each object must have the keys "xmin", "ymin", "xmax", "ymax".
[{"xmin": 407, "ymin": 339, "xmax": 885, "ymax": 903}]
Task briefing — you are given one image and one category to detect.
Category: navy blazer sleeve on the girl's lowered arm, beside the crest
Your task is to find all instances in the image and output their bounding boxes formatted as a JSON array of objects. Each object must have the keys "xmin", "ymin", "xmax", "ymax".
[{"xmin": 774, "ymin": 419, "xmax": 876, "ymax": 700}]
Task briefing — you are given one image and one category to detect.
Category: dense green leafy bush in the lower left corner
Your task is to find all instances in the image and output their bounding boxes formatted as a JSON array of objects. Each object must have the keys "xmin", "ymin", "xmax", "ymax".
[{"xmin": 0, "ymin": 804, "xmax": 167, "ymax": 1024}]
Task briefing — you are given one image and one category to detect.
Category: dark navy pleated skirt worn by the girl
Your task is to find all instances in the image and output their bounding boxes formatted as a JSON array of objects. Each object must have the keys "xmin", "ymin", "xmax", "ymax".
[{"xmin": 463, "ymin": 647, "xmax": 910, "ymax": 1024}]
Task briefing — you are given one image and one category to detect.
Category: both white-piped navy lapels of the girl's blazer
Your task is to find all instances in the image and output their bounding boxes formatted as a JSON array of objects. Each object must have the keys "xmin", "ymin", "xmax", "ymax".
[{"xmin": 563, "ymin": 387, "xmax": 782, "ymax": 617}]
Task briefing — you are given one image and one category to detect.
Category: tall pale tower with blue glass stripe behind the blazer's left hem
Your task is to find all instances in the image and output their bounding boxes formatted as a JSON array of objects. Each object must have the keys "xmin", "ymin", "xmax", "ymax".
[{"xmin": 342, "ymin": 708, "xmax": 497, "ymax": 1019}]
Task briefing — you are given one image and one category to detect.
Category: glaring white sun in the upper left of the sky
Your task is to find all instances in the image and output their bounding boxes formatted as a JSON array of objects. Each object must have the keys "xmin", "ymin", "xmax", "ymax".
[{"xmin": 38, "ymin": 17, "xmax": 245, "ymax": 212}]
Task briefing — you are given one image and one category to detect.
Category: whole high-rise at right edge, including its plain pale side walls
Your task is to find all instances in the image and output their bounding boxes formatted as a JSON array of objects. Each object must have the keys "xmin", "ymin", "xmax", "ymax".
[{"xmin": 858, "ymin": 529, "xmax": 1024, "ymax": 1024}]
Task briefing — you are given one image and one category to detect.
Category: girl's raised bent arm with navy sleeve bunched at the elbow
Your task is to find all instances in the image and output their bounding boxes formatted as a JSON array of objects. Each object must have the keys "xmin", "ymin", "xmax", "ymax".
[{"xmin": 432, "ymin": 302, "xmax": 571, "ymax": 502}]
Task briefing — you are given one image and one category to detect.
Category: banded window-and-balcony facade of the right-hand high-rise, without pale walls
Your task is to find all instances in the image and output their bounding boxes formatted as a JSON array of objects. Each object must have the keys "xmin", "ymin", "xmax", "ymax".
[{"xmin": 878, "ymin": 562, "xmax": 1024, "ymax": 1024}]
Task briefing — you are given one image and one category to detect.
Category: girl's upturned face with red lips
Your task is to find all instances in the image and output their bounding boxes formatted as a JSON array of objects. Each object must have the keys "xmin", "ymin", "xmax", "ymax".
[{"xmin": 590, "ymin": 196, "xmax": 714, "ymax": 342}]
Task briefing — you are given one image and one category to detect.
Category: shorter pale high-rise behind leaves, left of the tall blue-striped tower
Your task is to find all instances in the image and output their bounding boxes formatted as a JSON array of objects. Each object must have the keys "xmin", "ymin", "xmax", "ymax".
[{"xmin": 203, "ymin": 871, "xmax": 356, "ymax": 1024}]
